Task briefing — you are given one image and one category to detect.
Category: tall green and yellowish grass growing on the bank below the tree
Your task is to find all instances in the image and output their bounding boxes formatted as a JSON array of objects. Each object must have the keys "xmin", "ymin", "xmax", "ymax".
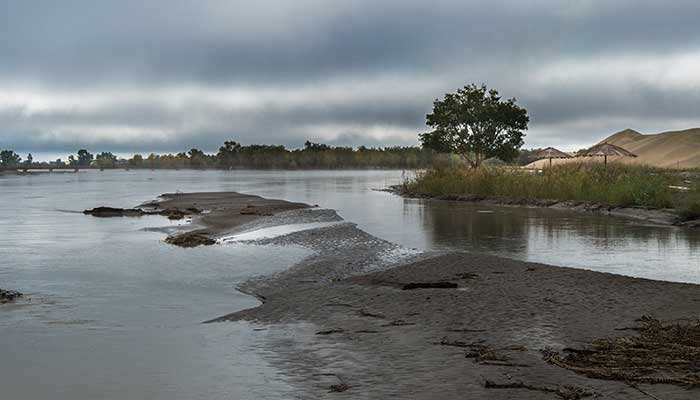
[{"xmin": 403, "ymin": 163, "xmax": 700, "ymax": 211}]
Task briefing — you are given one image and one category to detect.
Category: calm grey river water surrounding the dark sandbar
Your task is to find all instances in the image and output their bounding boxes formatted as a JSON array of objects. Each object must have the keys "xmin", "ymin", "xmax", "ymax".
[{"xmin": 0, "ymin": 171, "xmax": 700, "ymax": 400}]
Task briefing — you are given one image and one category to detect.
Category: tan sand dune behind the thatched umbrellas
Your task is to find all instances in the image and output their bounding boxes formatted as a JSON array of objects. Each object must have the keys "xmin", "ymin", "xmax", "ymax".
[{"xmin": 528, "ymin": 128, "xmax": 700, "ymax": 168}]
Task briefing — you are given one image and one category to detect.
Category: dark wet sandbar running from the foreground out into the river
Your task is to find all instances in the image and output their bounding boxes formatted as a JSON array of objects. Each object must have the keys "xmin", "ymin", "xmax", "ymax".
[{"xmin": 101, "ymin": 193, "xmax": 700, "ymax": 399}]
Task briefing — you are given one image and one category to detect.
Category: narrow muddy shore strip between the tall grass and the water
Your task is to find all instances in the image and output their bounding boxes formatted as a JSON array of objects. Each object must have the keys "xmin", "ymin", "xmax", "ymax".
[{"xmin": 382, "ymin": 185, "xmax": 700, "ymax": 228}]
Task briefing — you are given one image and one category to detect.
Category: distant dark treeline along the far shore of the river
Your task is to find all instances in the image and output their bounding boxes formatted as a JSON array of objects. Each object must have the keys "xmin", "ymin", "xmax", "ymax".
[{"xmin": 0, "ymin": 141, "xmax": 439, "ymax": 169}]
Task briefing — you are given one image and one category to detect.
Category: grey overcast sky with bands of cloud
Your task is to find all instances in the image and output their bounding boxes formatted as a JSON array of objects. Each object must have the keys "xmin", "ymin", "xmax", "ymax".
[{"xmin": 0, "ymin": 0, "xmax": 700, "ymax": 159}]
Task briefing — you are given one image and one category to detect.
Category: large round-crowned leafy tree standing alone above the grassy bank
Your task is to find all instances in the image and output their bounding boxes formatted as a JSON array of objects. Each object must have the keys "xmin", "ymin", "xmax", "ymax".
[{"xmin": 420, "ymin": 84, "xmax": 530, "ymax": 168}]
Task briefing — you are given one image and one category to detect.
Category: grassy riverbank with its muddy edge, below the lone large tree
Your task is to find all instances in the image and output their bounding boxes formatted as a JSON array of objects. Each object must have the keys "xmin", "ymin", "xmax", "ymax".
[{"xmin": 396, "ymin": 164, "xmax": 700, "ymax": 227}]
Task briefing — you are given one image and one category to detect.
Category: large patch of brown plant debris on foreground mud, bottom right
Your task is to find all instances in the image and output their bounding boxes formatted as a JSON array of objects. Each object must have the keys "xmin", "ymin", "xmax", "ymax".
[{"xmin": 544, "ymin": 317, "xmax": 700, "ymax": 387}]
